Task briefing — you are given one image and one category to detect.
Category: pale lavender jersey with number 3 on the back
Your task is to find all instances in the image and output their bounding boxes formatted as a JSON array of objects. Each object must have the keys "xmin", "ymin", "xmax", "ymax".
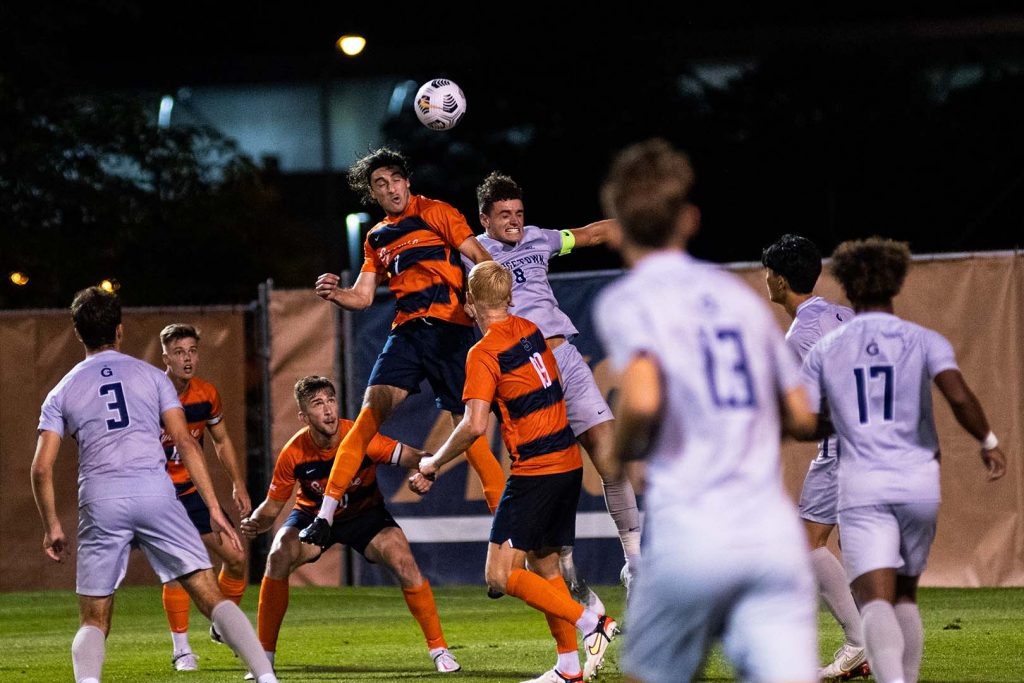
[{"xmin": 39, "ymin": 351, "xmax": 181, "ymax": 507}]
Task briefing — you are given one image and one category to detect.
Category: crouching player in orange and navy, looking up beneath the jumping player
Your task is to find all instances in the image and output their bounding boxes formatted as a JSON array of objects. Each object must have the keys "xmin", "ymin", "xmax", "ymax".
[{"xmin": 242, "ymin": 376, "xmax": 460, "ymax": 674}]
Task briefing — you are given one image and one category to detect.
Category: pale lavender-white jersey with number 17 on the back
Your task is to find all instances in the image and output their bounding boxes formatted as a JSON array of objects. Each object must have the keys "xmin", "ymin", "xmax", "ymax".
[{"xmin": 803, "ymin": 312, "xmax": 956, "ymax": 510}]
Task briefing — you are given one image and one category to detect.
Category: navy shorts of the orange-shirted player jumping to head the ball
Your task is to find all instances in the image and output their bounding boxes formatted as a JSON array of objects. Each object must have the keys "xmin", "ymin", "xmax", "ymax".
[{"xmin": 367, "ymin": 317, "xmax": 476, "ymax": 415}]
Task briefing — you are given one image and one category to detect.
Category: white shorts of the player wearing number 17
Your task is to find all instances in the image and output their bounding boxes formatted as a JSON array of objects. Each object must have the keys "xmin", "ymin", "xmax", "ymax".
[{"xmin": 839, "ymin": 501, "xmax": 939, "ymax": 582}]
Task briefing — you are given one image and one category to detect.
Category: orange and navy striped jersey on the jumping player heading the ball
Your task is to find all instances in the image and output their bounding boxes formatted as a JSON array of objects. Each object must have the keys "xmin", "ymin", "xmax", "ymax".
[{"xmin": 361, "ymin": 195, "xmax": 473, "ymax": 328}]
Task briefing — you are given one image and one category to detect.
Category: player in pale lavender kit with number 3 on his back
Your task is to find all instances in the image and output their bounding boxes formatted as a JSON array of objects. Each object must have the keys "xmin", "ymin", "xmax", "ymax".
[{"xmin": 32, "ymin": 287, "xmax": 278, "ymax": 683}]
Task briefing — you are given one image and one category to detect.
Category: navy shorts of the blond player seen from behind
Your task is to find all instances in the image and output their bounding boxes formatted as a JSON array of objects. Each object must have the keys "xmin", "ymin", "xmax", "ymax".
[{"xmin": 490, "ymin": 467, "xmax": 583, "ymax": 550}]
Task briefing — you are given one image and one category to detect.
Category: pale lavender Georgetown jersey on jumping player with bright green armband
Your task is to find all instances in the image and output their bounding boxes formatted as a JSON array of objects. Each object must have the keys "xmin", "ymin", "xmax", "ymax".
[{"xmin": 463, "ymin": 225, "xmax": 579, "ymax": 339}]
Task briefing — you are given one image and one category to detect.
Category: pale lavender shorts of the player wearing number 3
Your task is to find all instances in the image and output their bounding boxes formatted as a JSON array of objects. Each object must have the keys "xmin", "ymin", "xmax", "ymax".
[{"xmin": 75, "ymin": 496, "xmax": 212, "ymax": 597}]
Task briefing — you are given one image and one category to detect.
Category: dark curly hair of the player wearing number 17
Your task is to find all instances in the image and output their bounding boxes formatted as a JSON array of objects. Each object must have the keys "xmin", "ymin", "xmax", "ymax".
[{"xmin": 830, "ymin": 236, "xmax": 910, "ymax": 307}]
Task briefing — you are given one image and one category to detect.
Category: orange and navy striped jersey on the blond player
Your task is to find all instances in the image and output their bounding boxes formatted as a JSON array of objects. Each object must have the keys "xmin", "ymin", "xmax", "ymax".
[{"xmin": 462, "ymin": 315, "xmax": 583, "ymax": 475}]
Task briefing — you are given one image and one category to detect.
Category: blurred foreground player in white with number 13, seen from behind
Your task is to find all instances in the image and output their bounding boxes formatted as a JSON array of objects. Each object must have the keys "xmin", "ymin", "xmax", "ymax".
[{"xmin": 596, "ymin": 139, "xmax": 817, "ymax": 683}]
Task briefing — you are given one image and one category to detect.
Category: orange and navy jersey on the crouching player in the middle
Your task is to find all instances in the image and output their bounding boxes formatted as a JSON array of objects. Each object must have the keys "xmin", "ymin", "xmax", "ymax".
[{"xmin": 266, "ymin": 420, "xmax": 401, "ymax": 519}]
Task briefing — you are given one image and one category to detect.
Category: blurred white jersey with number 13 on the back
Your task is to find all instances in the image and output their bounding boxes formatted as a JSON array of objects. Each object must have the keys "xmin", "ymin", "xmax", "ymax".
[{"xmin": 596, "ymin": 252, "xmax": 803, "ymax": 532}]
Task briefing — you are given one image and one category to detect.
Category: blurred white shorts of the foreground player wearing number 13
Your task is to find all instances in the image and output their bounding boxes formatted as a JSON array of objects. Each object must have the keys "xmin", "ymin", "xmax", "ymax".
[{"xmin": 622, "ymin": 516, "xmax": 817, "ymax": 683}]
